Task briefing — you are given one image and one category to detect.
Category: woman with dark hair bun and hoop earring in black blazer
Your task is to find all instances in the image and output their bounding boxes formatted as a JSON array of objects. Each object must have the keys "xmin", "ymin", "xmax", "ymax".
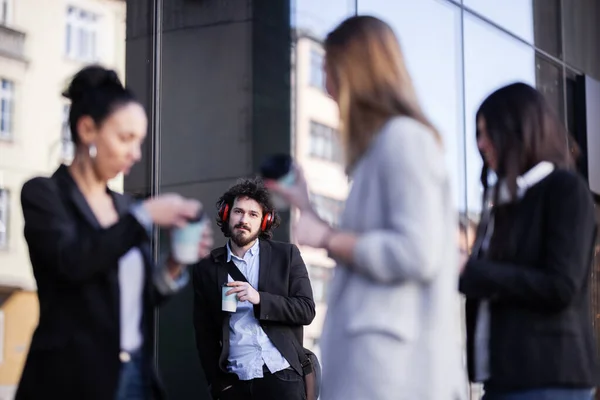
[{"xmin": 16, "ymin": 66, "xmax": 212, "ymax": 400}]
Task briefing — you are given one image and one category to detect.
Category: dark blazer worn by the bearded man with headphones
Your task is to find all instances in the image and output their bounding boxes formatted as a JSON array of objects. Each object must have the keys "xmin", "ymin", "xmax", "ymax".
[{"xmin": 192, "ymin": 240, "xmax": 315, "ymax": 396}]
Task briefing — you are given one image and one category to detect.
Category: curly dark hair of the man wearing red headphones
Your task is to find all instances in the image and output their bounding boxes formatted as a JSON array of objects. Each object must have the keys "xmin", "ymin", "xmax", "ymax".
[{"xmin": 216, "ymin": 177, "xmax": 281, "ymax": 239}]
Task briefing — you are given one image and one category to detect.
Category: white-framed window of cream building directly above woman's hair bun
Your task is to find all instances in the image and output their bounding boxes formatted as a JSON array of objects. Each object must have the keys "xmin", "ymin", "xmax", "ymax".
[{"xmin": 65, "ymin": 6, "xmax": 99, "ymax": 62}]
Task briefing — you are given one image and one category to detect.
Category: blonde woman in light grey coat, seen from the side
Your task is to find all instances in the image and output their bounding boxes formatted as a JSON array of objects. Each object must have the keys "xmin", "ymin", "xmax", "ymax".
[{"xmin": 268, "ymin": 16, "xmax": 464, "ymax": 400}]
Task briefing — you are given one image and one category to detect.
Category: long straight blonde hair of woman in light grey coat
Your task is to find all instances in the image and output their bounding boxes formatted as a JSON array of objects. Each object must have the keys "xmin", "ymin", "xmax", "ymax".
[{"xmin": 325, "ymin": 16, "xmax": 441, "ymax": 169}]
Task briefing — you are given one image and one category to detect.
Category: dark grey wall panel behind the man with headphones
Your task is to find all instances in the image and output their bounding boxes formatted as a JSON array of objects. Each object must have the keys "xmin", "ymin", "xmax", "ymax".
[{"xmin": 151, "ymin": 0, "xmax": 291, "ymax": 399}]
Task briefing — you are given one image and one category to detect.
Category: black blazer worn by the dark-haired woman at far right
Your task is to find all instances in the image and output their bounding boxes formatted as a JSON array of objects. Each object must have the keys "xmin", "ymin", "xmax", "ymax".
[{"xmin": 460, "ymin": 169, "xmax": 598, "ymax": 391}]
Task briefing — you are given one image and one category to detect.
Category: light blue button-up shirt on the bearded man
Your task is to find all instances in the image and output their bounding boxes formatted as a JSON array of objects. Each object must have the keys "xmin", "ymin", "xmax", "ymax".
[{"xmin": 227, "ymin": 240, "xmax": 290, "ymax": 381}]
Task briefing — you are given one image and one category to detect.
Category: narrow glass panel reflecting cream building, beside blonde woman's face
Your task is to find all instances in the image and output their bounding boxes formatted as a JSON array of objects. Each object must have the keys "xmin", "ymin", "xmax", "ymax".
[{"xmin": 291, "ymin": 0, "xmax": 356, "ymax": 362}]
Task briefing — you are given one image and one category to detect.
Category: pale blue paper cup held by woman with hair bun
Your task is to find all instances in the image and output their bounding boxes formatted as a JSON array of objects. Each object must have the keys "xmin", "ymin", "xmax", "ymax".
[{"xmin": 171, "ymin": 213, "xmax": 207, "ymax": 264}]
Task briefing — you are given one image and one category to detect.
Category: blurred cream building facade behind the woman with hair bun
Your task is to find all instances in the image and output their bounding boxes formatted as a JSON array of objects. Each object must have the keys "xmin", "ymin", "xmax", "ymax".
[{"xmin": 0, "ymin": 0, "xmax": 125, "ymax": 399}]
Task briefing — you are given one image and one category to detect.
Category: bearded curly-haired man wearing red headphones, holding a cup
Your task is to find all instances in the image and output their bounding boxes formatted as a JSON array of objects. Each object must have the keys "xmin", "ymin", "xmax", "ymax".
[{"xmin": 192, "ymin": 179, "xmax": 315, "ymax": 400}]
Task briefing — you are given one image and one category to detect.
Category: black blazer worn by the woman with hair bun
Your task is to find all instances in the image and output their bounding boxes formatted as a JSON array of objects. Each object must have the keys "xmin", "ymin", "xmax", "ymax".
[{"xmin": 16, "ymin": 165, "xmax": 171, "ymax": 400}]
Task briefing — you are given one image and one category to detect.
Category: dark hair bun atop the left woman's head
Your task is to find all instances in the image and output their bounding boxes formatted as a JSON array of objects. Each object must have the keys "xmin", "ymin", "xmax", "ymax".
[{"xmin": 63, "ymin": 65, "xmax": 125, "ymax": 101}]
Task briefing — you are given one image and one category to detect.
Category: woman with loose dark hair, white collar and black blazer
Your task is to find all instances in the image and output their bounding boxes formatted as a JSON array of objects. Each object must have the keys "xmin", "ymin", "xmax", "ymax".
[{"xmin": 460, "ymin": 83, "xmax": 598, "ymax": 400}]
